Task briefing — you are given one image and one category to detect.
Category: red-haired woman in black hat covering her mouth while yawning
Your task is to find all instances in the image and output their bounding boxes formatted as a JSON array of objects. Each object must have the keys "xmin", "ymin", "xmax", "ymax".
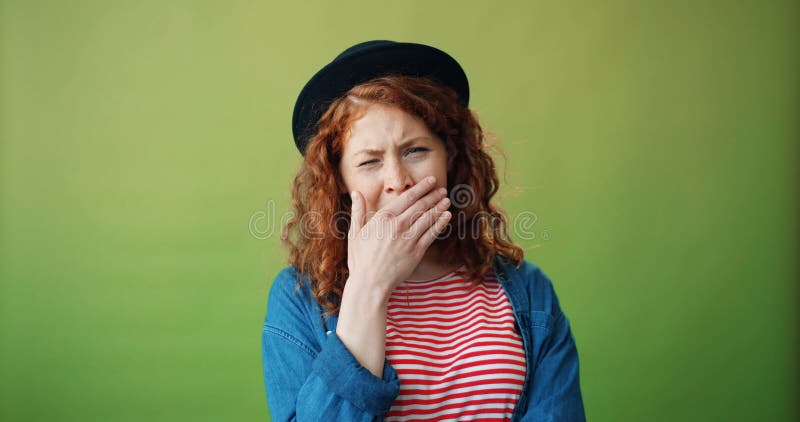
[{"xmin": 262, "ymin": 41, "xmax": 585, "ymax": 421}]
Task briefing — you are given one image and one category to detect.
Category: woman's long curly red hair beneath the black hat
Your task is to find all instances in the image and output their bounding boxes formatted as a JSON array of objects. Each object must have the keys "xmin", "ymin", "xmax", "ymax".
[{"xmin": 283, "ymin": 76, "xmax": 523, "ymax": 314}]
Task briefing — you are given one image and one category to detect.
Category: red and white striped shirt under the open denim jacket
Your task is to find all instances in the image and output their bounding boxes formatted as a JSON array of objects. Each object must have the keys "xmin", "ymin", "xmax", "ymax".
[{"xmin": 385, "ymin": 266, "xmax": 526, "ymax": 421}]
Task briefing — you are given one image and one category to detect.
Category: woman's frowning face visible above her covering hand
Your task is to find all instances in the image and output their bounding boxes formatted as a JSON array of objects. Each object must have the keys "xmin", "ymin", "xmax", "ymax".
[{"xmin": 339, "ymin": 104, "xmax": 447, "ymax": 213}]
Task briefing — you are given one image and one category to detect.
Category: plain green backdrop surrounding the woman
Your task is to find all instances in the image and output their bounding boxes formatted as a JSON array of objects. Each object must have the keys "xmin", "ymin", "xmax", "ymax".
[{"xmin": 0, "ymin": 0, "xmax": 800, "ymax": 421}]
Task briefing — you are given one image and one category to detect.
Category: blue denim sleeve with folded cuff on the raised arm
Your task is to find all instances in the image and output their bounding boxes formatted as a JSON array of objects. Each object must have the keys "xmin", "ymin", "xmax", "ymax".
[{"xmin": 262, "ymin": 270, "xmax": 400, "ymax": 422}]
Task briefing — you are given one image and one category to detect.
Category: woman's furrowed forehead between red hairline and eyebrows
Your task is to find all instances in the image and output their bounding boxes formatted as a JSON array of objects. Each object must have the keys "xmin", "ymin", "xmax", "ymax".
[{"xmin": 344, "ymin": 104, "xmax": 433, "ymax": 154}]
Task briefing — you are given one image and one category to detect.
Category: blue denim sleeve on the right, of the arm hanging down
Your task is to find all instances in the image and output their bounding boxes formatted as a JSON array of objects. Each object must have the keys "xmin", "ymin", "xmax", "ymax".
[{"xmin": 524, "ymin": 271, "xmax": 586, "ymax": 422}]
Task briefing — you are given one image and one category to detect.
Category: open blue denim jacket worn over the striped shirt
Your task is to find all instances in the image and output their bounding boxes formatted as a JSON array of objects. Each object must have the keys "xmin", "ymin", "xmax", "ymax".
[{"xmin": 262, "ymin": 256, "xmax": 585, "ymax": 422}]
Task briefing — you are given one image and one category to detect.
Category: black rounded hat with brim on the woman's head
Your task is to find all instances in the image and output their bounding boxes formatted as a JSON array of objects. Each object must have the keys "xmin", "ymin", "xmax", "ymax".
[{"xmin": 292, "ymin": 40, "xmax": 469, "ymax": 154}]
